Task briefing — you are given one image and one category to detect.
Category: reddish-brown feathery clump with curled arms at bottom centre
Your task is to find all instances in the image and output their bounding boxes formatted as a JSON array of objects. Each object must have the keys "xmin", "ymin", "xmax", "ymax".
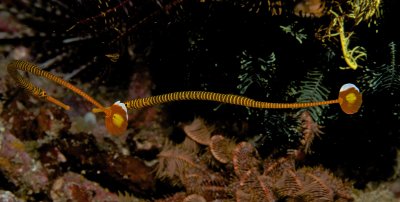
[{"xmin": 157, "ymin": 119, "xmax": 353, "ymax": 201}]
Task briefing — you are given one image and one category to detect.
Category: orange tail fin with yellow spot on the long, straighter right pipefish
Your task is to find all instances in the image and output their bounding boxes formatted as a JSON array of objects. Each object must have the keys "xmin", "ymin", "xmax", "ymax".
[{"xmin": 339, "ymin": 83, "xmax": 362, "ymax": 114}]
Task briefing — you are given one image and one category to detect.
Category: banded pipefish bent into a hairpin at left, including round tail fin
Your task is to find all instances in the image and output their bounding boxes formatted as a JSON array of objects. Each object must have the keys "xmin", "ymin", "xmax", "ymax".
[{"xmin": 7, "ymin": 60, "xmax": 128, "ymax": 135}]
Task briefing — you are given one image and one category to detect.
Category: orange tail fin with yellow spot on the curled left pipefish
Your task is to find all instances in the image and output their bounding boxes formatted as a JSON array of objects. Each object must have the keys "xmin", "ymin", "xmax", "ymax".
[{"xmin": 105, "ymin": 101, "xmax": 128, "ymax": 136}]
